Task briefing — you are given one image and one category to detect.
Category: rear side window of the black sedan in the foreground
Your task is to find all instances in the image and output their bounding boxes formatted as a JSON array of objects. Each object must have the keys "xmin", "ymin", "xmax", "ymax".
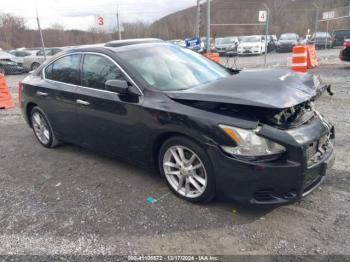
[{"xmin": 45, "ymin": 54, "xmax": 80, "ymax": 85}]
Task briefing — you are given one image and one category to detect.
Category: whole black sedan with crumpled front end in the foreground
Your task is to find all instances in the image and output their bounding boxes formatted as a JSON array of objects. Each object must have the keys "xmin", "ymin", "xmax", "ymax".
[{"xmin": 20, "ymin": 42, "xmax": 334, "ymax": 204}]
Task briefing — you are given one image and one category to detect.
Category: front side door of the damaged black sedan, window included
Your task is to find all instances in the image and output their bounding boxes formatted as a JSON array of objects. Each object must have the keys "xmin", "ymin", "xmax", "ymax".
[{"xmin": 77, "ymin": 53, "xmax": 143, "ymax": 159}]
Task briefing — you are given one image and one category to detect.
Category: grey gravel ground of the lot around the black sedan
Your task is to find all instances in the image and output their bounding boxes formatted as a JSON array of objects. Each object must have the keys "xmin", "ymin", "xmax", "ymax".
[{"xmin": 0, "ymin": 59, "xmax": 350, "ymax": 255}]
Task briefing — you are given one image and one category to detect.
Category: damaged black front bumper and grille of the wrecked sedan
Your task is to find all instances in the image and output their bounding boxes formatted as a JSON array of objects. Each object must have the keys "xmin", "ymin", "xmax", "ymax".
[{"xmin": 208, "ymin": 115, "xmax": 335, "ymax": 205}]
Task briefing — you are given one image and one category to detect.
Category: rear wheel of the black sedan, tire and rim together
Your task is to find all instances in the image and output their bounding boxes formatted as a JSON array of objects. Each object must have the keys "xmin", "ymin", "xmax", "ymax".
[{"xmin": 30, "ymin": 106, "xmax": 60, "ymax": 148}]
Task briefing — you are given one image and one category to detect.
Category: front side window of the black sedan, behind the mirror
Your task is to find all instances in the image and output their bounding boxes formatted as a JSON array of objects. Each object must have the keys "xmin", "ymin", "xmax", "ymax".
[{"xmin": 81, "ymin": 54, "xmax": 125, "ymax": 89}]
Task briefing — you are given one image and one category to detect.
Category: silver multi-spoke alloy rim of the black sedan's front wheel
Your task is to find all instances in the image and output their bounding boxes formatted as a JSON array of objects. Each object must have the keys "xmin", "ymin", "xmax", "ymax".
[{"xmin": 163, "ymin": 145, "xmax": 208, "ymax": 198}]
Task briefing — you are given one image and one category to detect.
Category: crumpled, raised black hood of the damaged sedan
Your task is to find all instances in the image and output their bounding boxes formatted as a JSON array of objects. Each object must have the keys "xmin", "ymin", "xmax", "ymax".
[{"xmin": 165, "ymin": 69, "xmax": 320, "ymax": 109}]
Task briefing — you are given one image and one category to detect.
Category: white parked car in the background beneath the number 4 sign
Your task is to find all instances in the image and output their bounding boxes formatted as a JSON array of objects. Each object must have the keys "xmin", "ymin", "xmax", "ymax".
[{"xmin": 237, "ymin": 35, "xmax": 266, "ymax": 55}]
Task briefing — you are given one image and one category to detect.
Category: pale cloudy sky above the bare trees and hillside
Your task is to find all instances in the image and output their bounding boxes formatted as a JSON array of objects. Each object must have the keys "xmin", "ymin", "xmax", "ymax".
[{"xmin": 0, "ymin": 0, "xmax": 197, "ymax": 30}]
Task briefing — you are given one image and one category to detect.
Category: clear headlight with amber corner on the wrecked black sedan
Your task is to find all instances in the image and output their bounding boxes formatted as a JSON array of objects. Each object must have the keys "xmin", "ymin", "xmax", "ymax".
[{"xmin": 219, "ymin": 125, "xmax": 286, "ymax": 158}]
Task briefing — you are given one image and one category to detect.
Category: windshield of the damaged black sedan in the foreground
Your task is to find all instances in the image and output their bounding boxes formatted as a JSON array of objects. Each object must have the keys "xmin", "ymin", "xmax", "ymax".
[{"xmin": 118, "ymin": 45, "xmax": 230, "ymax": 91}]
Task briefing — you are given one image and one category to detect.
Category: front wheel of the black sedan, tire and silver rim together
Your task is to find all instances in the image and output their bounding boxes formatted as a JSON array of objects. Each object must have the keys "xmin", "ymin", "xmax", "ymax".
[{"xmin": 158, "ymin": 136, "xmax": 215, "ymax": 203}]
